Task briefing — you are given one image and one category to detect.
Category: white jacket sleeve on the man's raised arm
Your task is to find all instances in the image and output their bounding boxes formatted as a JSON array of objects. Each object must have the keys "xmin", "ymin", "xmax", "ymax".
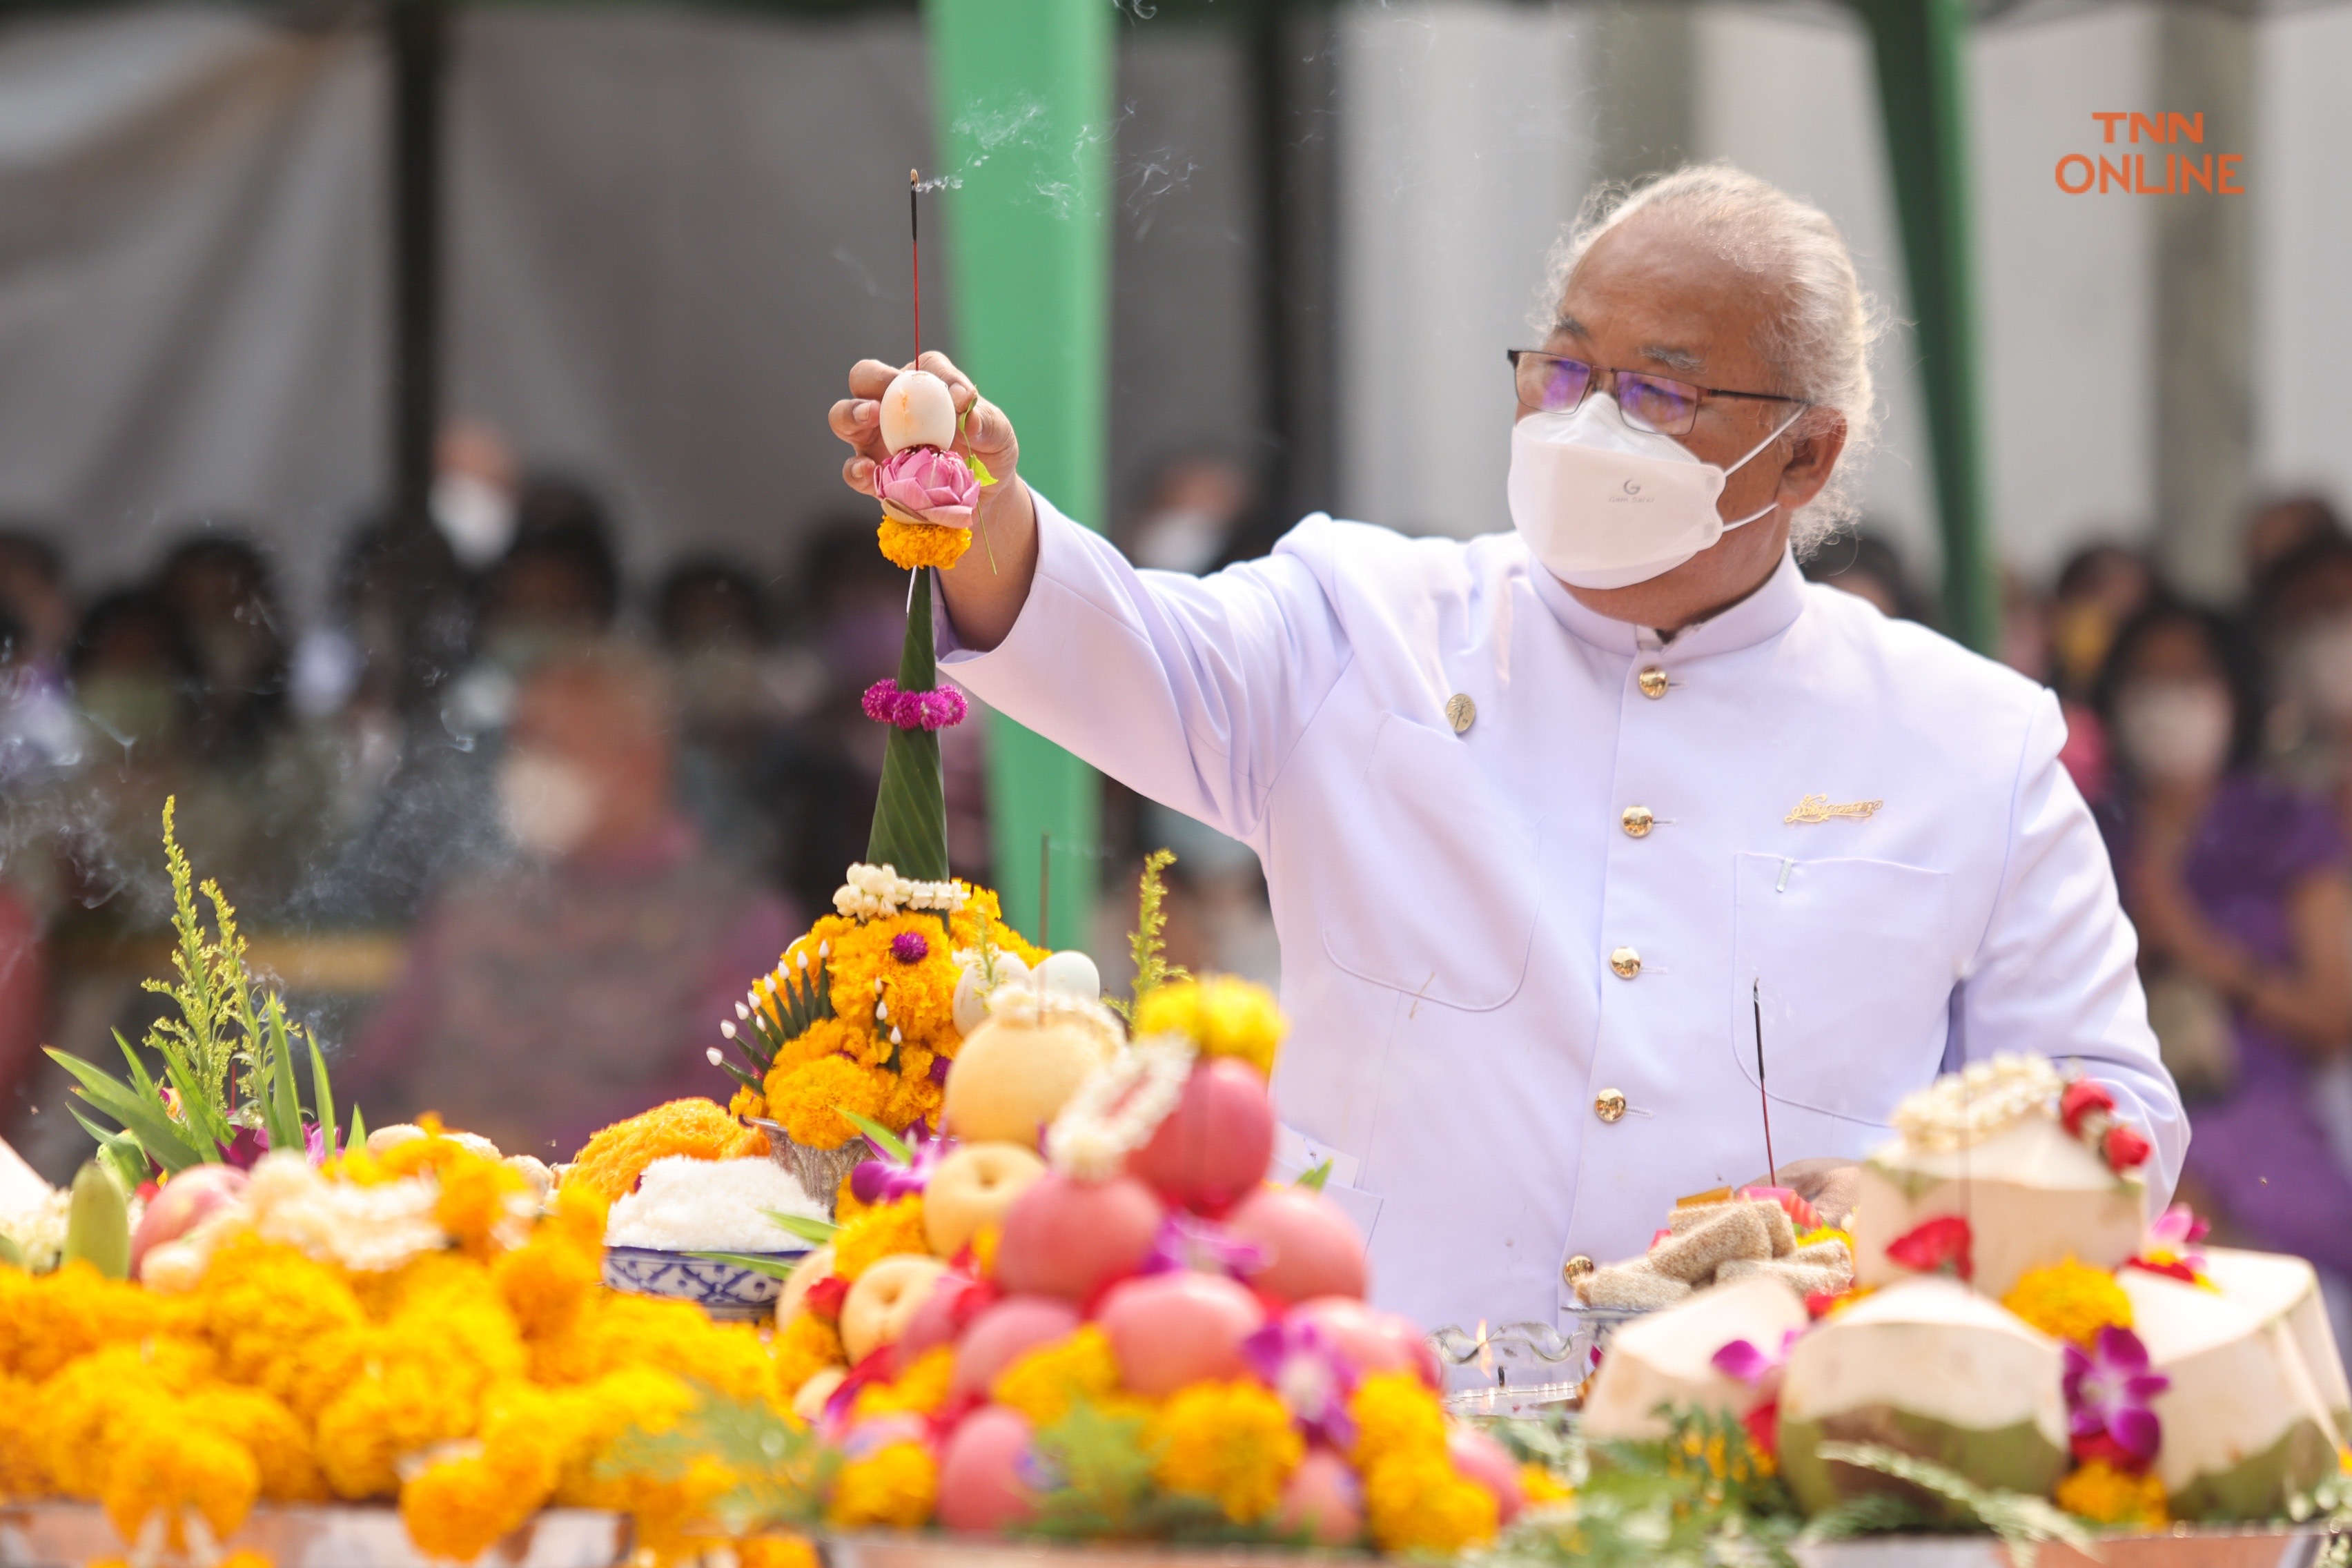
[{"xmin": 936, "ymin": 496, "xmax": 1348, "ymax": 849}]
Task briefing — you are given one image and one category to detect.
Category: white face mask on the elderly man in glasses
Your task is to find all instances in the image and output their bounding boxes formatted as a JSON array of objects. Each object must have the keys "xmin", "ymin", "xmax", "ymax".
[{"xmin": 1505, "ymin": 393, "xmax": 1804, "ymax": 588}]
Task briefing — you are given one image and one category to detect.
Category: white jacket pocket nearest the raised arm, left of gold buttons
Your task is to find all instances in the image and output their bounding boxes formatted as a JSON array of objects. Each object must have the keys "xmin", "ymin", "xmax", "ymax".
[{"xmin": 1322, "ymin": 715, "xmax": 1540, "ymax": 1013}]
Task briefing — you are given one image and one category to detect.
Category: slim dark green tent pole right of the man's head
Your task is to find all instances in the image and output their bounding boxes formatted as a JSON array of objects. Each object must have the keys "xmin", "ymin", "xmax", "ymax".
[{"xmin": 1856, "ymin": 0, "xmax": 2001, "ymax": 654}]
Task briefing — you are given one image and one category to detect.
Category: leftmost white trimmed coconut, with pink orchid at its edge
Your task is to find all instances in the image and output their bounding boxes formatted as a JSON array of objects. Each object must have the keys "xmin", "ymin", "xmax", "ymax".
[{"xmin": 1583, "ymin": 1277, "xmax": 1804, "ymax": 1441}]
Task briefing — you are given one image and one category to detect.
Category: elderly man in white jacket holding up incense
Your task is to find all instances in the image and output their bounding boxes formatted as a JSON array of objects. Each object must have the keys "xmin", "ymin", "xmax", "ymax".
[{"xmin": 832, "ymin": 167, "xmax": 2187, "ymax": 1324}]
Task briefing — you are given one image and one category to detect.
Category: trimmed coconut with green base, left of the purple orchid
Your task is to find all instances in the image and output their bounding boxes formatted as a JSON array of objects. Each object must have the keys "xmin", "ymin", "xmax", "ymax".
[{"xmin": 1781, "ymin": 1279, "xmax": 2068, "ymax": 1514}]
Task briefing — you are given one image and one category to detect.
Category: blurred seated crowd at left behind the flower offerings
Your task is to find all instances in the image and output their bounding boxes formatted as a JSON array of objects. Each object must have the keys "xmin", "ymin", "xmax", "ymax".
[{"xmin": 0, "ymin": 426, "xmax": 1273, "ymax": 1178}]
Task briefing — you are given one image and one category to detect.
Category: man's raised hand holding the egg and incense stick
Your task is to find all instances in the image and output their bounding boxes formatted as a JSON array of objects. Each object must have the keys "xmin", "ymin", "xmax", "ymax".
[{"xmin": 828, "ymin": 353, "xmax": 1037, "ymax": 651}]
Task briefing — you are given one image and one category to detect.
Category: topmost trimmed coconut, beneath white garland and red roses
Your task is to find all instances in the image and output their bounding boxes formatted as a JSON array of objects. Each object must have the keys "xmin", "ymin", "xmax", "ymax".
[{"xmin": 1851, "ymin": 1112, "xmax": 2148, "ymax": 1297}]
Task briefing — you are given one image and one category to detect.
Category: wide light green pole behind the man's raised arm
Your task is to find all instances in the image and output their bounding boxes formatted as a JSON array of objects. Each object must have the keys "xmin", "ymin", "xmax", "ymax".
[{"xmin": 924, "ymin": 0, "xmax": 1115, "ymax": 948}]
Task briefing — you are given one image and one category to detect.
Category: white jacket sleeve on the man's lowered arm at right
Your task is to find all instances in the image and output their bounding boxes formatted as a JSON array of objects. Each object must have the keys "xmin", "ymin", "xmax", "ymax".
[{"xmin": 1954, "ymin": 691, "xmax": 2190, "ymax": 1215}]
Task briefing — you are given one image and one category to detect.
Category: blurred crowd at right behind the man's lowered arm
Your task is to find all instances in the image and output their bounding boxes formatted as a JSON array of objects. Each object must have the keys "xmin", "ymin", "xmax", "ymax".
[{"xmin": 1809, "ymin": 496, "xmax": 2352, "ymax": 1317}]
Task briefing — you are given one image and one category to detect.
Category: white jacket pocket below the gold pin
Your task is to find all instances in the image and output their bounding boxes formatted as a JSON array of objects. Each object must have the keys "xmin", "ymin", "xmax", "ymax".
[{"xmin": 1729, "ymin": 853, "xmax": 1959, "ymax": 1126}]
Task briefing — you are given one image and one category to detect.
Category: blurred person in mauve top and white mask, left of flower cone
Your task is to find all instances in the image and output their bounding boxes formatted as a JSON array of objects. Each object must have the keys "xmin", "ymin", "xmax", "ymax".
[{"xmin": 339, "ymin": 644, "xmax": 797, "ymax": 1157}]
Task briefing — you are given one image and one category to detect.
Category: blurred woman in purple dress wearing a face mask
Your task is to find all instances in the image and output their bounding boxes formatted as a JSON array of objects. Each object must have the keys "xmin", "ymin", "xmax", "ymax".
[{"xmin": 2098, "ymin": 602, "xmax": 2352, "ymax": 1335}]
